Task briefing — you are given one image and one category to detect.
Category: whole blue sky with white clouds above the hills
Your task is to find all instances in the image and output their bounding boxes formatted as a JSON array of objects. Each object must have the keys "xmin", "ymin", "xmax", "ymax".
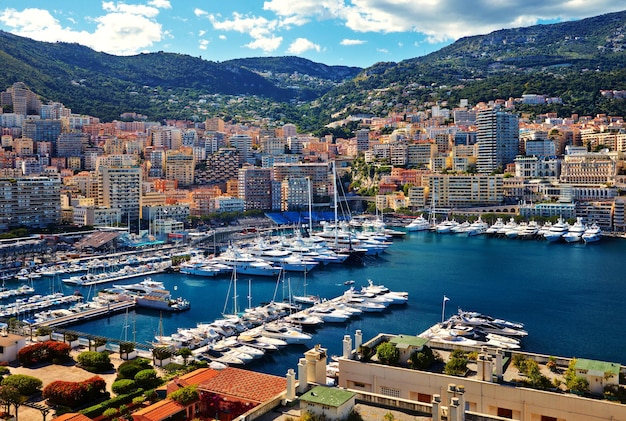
[{"xmin": 0, "ymin": 0, "xmax": 624, "ymax": 67}]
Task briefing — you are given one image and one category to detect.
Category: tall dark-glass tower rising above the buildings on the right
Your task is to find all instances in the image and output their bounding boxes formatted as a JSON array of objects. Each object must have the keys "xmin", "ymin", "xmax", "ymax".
[{"xmin": 476, "ymin": 107, "xmax": 519, "ymax": 174}]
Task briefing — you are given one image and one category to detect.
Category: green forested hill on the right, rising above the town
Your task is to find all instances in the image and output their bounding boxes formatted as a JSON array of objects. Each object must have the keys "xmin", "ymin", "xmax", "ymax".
[{"xmin": 316, "ymin": 11, "xmax": 626, "ymax": 124}]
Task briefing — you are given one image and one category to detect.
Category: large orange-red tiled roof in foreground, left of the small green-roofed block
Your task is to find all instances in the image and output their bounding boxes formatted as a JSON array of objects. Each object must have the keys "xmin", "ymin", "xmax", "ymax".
[{"xmin": 198, "ymin": 367, "xmax": 287, "ymax": 403}]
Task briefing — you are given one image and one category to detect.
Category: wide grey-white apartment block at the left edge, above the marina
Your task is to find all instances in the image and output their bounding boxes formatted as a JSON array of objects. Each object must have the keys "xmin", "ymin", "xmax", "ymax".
[{"xmin": 0, "ymin": 177, "xmax": 61, "ymax": 230}]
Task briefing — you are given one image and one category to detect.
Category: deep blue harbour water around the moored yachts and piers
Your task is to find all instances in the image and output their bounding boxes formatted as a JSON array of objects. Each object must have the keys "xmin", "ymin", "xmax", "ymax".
[{"xmin": 14, "ymin": 232, "xmax": 626, "ymax": 375}]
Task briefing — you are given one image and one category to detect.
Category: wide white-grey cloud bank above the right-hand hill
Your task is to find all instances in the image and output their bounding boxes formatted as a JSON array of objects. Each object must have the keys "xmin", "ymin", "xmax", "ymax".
[{"xmin": 263, "ymin": 0, "xmax": 623, "ymax": 43}]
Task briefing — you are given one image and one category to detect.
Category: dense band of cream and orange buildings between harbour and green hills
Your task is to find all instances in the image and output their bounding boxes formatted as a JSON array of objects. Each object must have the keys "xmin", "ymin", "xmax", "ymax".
[{"xmin": 0, "ymin": 83, "xmax": 626, "ymax": 236}]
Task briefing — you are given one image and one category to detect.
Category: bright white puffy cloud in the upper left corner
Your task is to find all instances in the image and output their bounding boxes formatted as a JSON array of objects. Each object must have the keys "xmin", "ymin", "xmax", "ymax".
[{"xmin": 0, "ymin": 0, "xmax": 169, "ymax": 55}]
